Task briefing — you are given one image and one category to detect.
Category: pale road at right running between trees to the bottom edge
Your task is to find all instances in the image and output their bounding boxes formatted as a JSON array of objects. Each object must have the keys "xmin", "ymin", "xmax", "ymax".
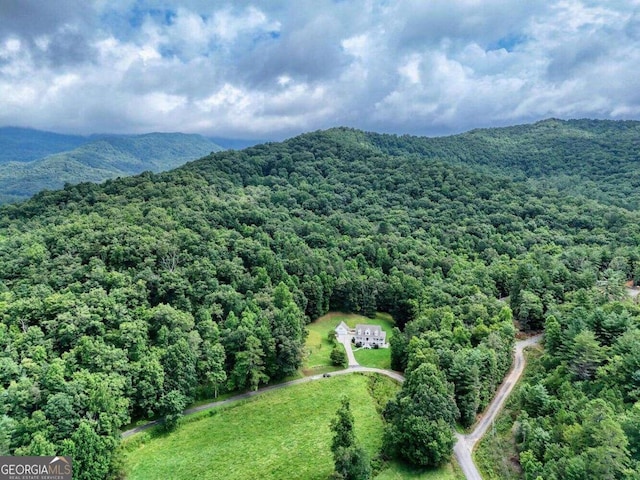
[{"xmin": 453, "ymin": 335, "xmax": 542, "ymax": 480}]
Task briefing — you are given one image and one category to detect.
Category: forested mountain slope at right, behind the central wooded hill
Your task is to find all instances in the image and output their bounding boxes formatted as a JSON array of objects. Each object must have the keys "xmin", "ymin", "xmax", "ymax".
[{"xmin": 360, "ymin": 119, "xmax": 640, "ymax": 210}]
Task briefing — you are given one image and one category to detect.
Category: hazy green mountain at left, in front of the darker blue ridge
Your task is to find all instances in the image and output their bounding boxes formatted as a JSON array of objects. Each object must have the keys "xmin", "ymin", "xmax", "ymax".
[{"xmin": 0, "ymin": 132, "xmax": 221, "ymax": 202}]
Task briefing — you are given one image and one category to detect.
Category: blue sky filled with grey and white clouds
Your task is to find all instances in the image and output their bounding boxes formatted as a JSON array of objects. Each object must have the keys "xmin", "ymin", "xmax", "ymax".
[{"xmin": 0, "ymin": 0, "xmax": 640, "ymax": 139}]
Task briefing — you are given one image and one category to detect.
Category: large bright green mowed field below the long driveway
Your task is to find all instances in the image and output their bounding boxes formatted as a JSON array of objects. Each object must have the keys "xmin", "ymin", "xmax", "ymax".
[{"xmin": 125, "ymin": 374, "xmax": 399, "ymax": 480}]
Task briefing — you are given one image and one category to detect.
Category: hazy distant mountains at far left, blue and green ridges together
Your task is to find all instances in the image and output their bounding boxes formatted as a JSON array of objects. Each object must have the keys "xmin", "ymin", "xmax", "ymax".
[{"xmin": 0, "ymin": 127, "xmax": 223, "ymax": 203}]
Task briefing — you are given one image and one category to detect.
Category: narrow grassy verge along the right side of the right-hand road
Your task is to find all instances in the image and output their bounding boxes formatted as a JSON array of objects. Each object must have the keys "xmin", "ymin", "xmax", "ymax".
[{"xmin": 473, "ymin": 349, "xmax": 542, "ymax": 480}]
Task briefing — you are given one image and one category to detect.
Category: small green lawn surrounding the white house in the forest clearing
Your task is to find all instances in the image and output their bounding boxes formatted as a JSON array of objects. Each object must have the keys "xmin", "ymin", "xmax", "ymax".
[{"xmin": 304, "ymin": 312, "xmax": 393, "ymax": 375}]
